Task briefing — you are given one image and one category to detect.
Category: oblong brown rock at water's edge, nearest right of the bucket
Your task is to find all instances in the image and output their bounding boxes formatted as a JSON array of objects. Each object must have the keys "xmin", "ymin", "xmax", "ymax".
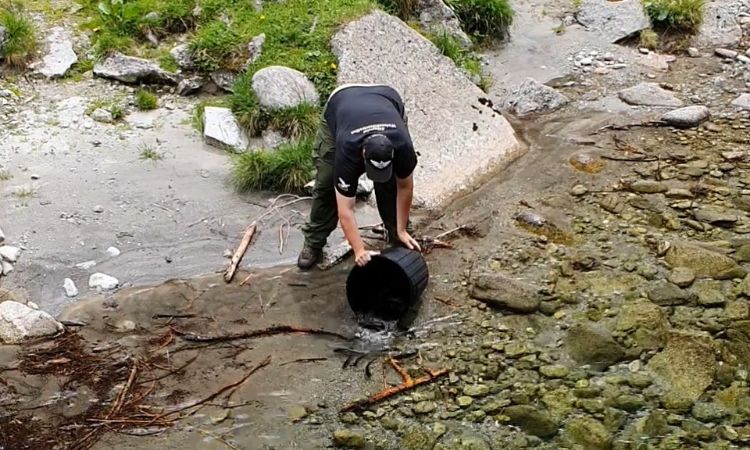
[{"xmin": 471, "ymin": 271, "xmax": 541, "ymax": 313}]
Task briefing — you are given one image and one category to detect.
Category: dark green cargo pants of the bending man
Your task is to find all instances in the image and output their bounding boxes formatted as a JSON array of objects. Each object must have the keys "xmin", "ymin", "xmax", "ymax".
[{"xmin": 302, "ymin": 117, "xmax": 398, "ymax": 249}]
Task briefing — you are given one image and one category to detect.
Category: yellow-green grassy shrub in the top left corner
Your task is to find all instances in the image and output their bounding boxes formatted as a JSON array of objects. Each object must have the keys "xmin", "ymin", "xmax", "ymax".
[{"xmin": 0, "ymin": 1, "xmax": 38, "ymax": 69}]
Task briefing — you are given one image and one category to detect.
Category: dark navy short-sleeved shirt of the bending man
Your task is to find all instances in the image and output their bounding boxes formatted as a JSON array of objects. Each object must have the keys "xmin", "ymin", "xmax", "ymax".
[{"xmin": 324, "ymin": 86, "xmax": 417, "ymax": 197}]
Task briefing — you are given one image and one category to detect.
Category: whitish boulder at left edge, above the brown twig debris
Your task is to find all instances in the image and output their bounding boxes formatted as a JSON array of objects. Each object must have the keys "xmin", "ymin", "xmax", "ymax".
[{"xmin": 0, "ymin": 301, "xmax": 63, "ymax": 344}]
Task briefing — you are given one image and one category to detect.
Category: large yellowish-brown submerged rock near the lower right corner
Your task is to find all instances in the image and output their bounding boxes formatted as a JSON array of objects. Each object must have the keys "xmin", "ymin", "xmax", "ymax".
[{"xmin": 646, "ymin": 331, "xmax": 716, "ymax": 401}]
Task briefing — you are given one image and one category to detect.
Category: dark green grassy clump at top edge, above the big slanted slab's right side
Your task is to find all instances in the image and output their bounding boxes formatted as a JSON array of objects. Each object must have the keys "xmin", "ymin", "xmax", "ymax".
[{"xmin": 448, "ymin": 0, "xmax": 513, "ymax": 41}]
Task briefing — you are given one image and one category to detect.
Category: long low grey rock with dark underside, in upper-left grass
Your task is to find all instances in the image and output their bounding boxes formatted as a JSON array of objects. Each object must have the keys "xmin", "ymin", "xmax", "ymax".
[{"xmin": 94, "ymin": 53, "xmax": 178, "ymax": 85}]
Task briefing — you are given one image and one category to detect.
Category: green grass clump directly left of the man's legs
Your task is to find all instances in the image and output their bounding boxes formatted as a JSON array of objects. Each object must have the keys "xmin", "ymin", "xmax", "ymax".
[{"xmin": 232, "ymin": 138, "xmax": 313, "ymax": 192}]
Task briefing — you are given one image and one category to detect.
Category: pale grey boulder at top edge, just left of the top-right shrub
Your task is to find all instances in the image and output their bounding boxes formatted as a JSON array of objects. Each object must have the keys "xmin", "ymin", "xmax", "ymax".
[{"xmin": 576, "ymin": 0, "xmax": 651, "ymax": 42}]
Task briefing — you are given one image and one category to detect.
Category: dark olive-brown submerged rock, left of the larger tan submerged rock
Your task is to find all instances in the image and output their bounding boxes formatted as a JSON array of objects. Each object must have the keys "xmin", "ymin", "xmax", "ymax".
[{"xmin": 565, "ymin": 324, "xmax": 625, "ymax": 370}]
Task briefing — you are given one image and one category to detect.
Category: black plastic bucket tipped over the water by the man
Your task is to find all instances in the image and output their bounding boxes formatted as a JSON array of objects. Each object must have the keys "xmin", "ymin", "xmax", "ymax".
[{"xmin": 346, "ymin": 247, "xmax": 430, "ymax": 321}]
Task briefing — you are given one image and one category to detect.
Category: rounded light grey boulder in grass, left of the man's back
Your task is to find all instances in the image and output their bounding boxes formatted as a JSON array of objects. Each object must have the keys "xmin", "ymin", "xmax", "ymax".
[{"xmin": 253, "ymin": 66, "xmax": 320, "ymax": 109}]
